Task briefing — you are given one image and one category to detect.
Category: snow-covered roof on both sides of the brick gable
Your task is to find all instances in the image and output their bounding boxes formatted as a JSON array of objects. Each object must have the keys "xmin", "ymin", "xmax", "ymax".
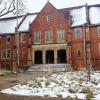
[{"xmin": 0, "ymin": 2, "xmax": 100, "ymax": 34}]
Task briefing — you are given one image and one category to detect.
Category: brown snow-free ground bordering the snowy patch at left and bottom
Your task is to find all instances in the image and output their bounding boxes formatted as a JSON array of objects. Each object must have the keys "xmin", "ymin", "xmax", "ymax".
[{"xmin": 0, "ymin": 72, "xmax": 83, "ymax": 100}]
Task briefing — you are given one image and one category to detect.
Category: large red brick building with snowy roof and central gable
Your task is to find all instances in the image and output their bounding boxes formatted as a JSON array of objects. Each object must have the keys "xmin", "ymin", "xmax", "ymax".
[{"xmin": 0, "ymin": 2, "xmax": 100, "ymax": 70}]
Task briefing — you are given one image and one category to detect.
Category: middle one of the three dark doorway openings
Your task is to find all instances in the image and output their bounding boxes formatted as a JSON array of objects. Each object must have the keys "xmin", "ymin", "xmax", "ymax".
[{"xmin": 46, "ymin": 50, "xmax": 54, "ymax": 64}]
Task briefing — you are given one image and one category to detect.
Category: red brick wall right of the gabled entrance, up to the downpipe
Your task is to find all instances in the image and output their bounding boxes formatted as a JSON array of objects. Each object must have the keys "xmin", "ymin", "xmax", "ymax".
[{"xmin": 71, "ymin": 27, "xmax": 84, "ymax": 70}]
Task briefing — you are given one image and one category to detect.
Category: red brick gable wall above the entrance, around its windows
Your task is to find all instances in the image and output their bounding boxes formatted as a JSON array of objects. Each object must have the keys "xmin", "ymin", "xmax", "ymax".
[{"xmin": 30, "ymin": 4, "xmax": 68, "ymax": 44}]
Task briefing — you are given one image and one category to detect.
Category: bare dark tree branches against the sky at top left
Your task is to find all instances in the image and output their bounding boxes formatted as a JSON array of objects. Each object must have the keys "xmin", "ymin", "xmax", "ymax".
[{"xmin": 0, "ymin": 0, "xmax": 26, "ymax": 17}]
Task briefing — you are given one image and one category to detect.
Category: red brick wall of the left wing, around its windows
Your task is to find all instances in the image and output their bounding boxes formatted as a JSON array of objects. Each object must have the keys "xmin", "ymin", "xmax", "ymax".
[{"xmin": 0, "ymin": 33, "xmax": 29, "ymax": 69}]
